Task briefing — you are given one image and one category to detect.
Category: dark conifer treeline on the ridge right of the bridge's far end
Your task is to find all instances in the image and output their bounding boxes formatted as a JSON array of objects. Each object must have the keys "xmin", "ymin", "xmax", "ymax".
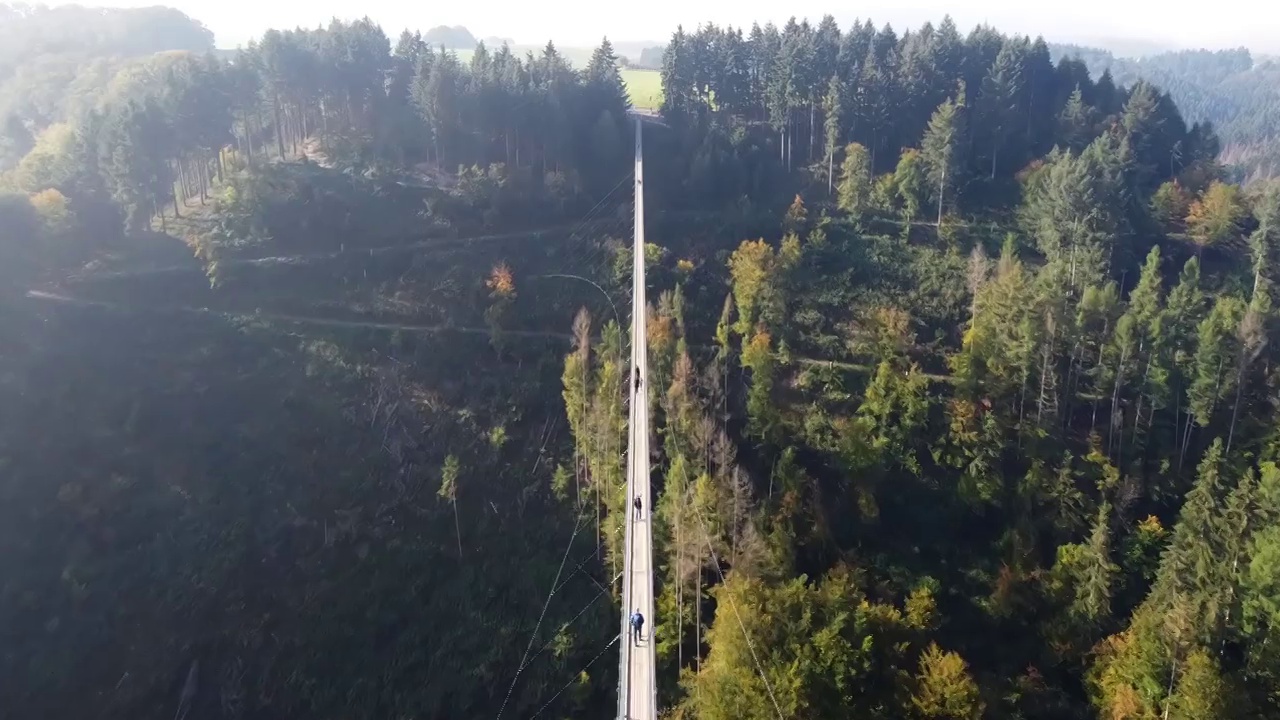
[{"xmin": 663, "ymin": 17, "xmax": 1217, "ymax": 210}]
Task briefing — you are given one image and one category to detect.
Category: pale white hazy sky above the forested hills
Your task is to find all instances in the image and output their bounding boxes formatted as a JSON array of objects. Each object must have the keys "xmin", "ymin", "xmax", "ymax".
[{"xmin": 49, "ymin": 0, "xmax": 1280, "ymax": 54}]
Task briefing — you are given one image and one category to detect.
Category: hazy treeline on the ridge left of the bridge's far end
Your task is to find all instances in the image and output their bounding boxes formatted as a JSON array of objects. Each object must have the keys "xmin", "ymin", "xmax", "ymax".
[{"xmin": 3, "ymin": 13, "xmax": 630, "ymax": 283}]
